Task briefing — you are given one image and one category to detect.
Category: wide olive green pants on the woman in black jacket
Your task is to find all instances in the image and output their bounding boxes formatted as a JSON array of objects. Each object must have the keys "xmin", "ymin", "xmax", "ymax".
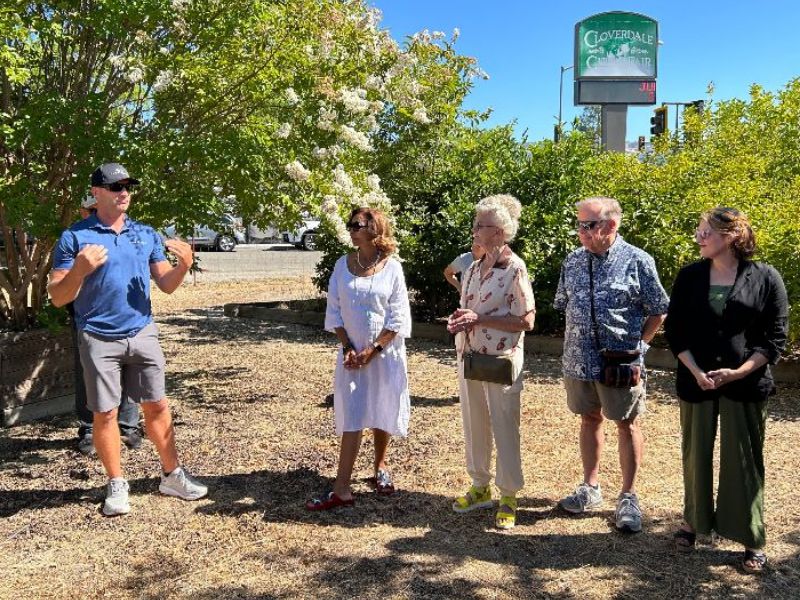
[{"xmin": 681, "ymin": 396, "xmax": 767, "ymax": 549}]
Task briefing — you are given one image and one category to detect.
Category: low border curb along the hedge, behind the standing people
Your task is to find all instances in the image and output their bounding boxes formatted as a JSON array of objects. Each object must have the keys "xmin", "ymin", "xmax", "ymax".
[{"xmin": 224, "ymin": 302, "xmax": 800, "ymax": 383}]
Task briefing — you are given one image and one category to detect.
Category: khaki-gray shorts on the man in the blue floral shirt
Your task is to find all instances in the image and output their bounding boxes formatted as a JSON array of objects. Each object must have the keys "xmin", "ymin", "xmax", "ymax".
[{"xmin": 564, "ymin": 377, "xmax": 645, "ymax": 421}]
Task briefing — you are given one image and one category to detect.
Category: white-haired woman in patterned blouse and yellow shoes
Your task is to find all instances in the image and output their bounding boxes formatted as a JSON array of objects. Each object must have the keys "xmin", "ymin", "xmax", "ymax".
[{"xmin": 448, "ymin": 195, "xmax": 536, "ymax": 529}]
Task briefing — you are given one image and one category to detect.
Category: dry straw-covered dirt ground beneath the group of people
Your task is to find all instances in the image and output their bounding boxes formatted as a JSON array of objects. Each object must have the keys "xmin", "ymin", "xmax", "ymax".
[{"xmin": 0, "ymin": 279, "xmax": 800, "ymax": 600}]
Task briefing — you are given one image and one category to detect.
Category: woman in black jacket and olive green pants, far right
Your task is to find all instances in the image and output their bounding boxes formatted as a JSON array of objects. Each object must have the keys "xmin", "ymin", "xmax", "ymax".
[{"xmin": 664, "ymin": 207, "xmax": 789, "ymax": 573}]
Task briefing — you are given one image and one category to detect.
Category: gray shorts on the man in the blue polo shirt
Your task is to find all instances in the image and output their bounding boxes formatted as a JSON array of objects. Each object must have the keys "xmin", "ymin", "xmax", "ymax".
[{"xmin": 78, "ymin": 323, "xmax": 166, "ymax": 412}]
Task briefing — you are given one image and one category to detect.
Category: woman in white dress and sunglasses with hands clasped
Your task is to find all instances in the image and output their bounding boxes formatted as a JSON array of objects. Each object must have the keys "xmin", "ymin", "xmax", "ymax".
[{"xmin": 306, "ymin": 208, "xmax": 411, "ymax": 511}]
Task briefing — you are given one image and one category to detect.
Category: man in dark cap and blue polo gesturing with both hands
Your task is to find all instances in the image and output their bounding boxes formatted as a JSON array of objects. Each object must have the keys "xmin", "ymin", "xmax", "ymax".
[{"xmin": 48, "ymin": 163, "xmax": 208, "ymax": 516}]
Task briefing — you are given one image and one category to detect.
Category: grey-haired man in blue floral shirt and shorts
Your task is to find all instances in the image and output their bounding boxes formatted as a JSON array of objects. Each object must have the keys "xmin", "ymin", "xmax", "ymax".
[{"xmin": 553, "ymin": 197, "xmax": 669, "ymax": 531}]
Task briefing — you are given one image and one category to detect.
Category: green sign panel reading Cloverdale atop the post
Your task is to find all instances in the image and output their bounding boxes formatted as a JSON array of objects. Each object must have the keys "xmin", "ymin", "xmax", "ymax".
[{"xmin": 575, "ymin": 12, "xmax": 658, "ymax": 78}]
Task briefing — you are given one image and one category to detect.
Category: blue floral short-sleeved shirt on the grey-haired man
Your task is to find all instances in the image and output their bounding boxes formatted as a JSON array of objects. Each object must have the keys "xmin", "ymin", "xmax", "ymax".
[{"xmin": 553, "ymin": 235, "xmax": 669, "ymax": 381}]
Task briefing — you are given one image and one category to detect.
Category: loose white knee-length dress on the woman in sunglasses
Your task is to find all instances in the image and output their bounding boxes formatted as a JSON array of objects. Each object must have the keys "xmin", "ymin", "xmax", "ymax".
[{"xmin": 325, "ymin": 256, "xmax": 411, "ymax": 436}]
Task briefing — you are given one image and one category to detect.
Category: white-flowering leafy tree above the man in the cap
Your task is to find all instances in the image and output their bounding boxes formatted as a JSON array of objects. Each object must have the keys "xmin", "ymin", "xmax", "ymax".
[{"xmin": 0, "ymin": 0, "xmax": 475, "ymax": 327}]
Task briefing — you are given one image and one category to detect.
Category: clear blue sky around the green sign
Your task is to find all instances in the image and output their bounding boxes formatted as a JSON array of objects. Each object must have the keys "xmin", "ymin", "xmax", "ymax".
[{"xmin": 378, "ymin": 0, "xmax": 800, "ymax": 140}]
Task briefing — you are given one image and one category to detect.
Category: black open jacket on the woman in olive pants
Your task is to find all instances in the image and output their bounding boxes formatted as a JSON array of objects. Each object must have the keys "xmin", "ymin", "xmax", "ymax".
[{"xmin": 664, "ymin": 260, "xmax": 789, "ymax": 402}]
